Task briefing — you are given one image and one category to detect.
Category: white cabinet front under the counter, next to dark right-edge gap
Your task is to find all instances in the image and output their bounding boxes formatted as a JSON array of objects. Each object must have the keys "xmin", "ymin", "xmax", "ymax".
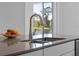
[{"xmin": 44, "ymin": 41, "xmax": 74, "ymax": 56}]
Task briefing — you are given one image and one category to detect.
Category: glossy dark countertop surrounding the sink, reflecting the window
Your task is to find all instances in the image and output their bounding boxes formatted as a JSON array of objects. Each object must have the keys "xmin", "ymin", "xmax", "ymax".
[{"xmin": 0, "ymin": 35, "xmax": 79, "ymax": 56}]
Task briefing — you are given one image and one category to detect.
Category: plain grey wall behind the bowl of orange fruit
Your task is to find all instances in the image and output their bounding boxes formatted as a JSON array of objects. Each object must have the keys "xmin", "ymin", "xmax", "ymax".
[{"xmin": 0, "ymin": 2, "xmax": 25, "ymax": 34}]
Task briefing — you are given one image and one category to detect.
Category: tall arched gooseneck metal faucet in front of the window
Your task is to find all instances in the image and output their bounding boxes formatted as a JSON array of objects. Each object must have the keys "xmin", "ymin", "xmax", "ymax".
[{"xmin": 29, "ymin": 14, "xmax": 44, "ymax": 40}]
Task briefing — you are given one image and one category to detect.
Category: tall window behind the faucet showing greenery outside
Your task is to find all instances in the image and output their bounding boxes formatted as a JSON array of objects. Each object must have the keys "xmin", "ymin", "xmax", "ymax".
[{"xmin": 32, "ymin": 2, "xmax": 53, "ymax": 38}]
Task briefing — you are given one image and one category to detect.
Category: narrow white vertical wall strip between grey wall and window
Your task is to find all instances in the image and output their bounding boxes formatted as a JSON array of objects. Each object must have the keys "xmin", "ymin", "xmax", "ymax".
[{"xmin": 25, "ymin": 2, "xmax": 33, "ymax": 35}]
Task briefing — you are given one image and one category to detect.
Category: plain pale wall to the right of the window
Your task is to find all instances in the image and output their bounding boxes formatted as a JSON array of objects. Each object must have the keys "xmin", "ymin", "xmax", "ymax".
[{"xmin": 56, "ymin": 2, "xmax": 79, "ymax": 35}]
